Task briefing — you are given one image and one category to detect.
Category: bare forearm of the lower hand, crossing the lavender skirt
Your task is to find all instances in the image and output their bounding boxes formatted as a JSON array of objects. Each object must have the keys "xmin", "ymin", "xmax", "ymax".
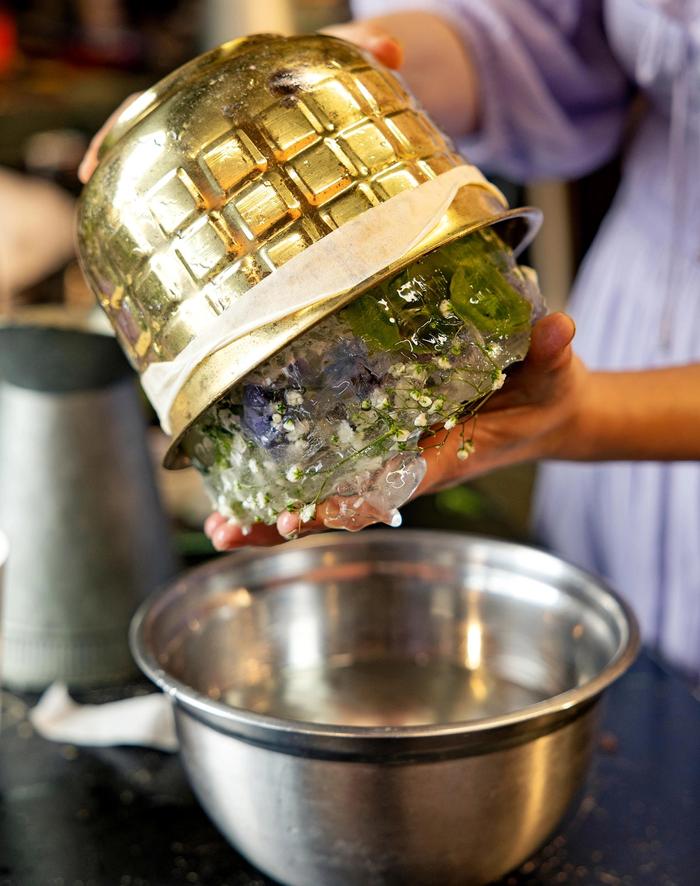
[{"xmin": 553, "ymin": 364, "xmax": 700, "ymax": 461}]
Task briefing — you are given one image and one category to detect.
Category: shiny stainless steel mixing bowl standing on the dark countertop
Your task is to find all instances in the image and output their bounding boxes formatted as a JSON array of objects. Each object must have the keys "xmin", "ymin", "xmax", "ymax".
[{"xmin": 132, "ymin": 531, "xmax": 638, "ymax": 886}]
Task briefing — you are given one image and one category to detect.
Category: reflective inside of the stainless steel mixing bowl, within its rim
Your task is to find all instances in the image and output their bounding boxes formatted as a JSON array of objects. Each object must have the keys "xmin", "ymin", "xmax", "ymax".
[{"xmin": 153, "ymin": 534, "xmax": 622, "ymax": 727}]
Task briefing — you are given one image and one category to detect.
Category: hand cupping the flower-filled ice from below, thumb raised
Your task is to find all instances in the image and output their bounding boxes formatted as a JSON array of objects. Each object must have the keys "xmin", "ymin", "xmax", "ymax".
[{"xmin": 205, "ymin": 314, "xmax": 589, "ymax": 550}]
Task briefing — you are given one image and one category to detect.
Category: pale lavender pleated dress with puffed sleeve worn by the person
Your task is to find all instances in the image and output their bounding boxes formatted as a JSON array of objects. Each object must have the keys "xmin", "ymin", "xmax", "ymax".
[{"xmin": 354, "ymin": 0, "xmax": 700, "ymax": 673}]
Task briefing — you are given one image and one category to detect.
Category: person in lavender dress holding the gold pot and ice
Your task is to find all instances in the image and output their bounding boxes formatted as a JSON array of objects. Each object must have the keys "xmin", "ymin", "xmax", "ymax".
[{"xmin": 82, "ymin": 0, "xmax": 700, "ymax": 674}]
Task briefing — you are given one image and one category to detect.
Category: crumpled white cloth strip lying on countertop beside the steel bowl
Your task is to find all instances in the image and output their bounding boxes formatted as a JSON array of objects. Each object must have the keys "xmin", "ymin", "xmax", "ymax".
[{"xmin": 29, "ymin": 683, "xmax": 178, "ymax": 751}]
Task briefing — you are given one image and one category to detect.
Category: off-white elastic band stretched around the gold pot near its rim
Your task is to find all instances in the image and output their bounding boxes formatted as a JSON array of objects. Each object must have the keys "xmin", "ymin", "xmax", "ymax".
[{"xmin": 141, "ymin": 165, "xmax": 506, "ymax": 434}]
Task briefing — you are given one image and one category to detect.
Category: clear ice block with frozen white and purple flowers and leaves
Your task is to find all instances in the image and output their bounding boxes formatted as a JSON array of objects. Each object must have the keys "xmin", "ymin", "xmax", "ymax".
[{"xmin": 184, "ymin": 230, "xmax": 544, "ymax": 529}]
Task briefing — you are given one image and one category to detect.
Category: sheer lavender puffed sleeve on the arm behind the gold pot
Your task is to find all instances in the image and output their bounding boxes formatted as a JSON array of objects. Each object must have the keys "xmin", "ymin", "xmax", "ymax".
[{"xmin": 353, "ymin": 0, "xmax": 630, "ymax": 181}]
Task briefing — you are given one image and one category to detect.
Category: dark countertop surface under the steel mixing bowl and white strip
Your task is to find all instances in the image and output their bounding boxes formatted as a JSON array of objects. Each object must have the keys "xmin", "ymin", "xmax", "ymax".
[{"xmin": 0, "ymin": 655, "xmax": 700, "ymax": 886}]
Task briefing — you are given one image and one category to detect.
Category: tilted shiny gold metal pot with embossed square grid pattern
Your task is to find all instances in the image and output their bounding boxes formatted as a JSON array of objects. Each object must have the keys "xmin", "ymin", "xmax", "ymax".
[{"xmin": 78, "ymin": 35, "xmax": 539, "ymax": 467}]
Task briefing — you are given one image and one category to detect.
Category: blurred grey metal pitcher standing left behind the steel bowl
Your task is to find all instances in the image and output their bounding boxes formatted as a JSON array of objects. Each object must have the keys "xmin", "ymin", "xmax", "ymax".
[{"xmin": 0, "ymin": 323, "xmax": 174, "ymax": 689}]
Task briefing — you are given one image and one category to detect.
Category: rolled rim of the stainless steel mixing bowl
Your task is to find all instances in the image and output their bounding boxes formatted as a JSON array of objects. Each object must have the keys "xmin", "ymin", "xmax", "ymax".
[{"xmin": 129, "ymin": 529, "xmax": 640, "ymax": 741}]
